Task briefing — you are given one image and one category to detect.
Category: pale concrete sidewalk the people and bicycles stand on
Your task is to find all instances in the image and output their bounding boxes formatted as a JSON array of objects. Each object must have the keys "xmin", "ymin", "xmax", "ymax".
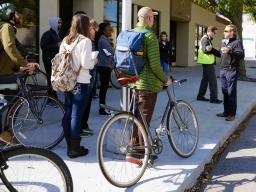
[{"xmin": 54, "ymin": 63, "xmax": 256, "ymax": 192}]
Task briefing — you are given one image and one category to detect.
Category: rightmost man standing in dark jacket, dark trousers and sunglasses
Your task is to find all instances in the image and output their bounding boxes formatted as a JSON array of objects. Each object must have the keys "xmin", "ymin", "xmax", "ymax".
[{"xmin": 217, "ymin": 25, "xmax": 244, "ymax": 121}]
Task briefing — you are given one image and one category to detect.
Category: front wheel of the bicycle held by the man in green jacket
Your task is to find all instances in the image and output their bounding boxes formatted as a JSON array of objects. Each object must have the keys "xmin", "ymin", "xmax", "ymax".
[{"xmin": 166, "ymin": 100, "xmax": 199, "ymax": 158}]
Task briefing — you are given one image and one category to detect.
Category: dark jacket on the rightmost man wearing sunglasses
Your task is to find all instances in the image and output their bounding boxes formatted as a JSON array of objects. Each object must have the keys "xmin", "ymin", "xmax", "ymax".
[{"xmin": 220, "ymin": 38, "xmax": 244, "ymax": 70}]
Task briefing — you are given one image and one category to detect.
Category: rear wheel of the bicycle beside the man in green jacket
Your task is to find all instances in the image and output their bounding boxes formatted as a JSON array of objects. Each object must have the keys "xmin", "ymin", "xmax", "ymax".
[{"xmin": 98, "ymin": 113, "xmax": 149, "ymax": 187}]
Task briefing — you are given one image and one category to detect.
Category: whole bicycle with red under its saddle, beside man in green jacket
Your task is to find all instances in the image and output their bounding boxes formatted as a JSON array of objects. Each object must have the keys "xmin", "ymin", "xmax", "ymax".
[{"xmin": 97, "ymin": 78, "xmax": 199, "ymax": 187}]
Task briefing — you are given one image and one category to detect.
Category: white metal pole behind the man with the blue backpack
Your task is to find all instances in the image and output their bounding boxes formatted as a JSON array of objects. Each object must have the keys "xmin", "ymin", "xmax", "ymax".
[{"xmin": 122, "ymin": 0, "xmax": 132, "ymax": 110}]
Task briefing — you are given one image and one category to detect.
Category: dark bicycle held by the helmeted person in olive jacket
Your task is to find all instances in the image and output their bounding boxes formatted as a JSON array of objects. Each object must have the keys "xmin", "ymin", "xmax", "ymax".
[{"xmin": 0, "ymin": 68, "xmax": 64, "ymax": 149}]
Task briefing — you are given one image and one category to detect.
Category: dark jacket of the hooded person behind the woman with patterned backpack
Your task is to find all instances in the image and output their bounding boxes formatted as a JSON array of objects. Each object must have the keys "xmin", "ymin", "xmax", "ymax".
[{"xmin": 41, "ymin": 29, "xmax": 61, "ymax": 65}]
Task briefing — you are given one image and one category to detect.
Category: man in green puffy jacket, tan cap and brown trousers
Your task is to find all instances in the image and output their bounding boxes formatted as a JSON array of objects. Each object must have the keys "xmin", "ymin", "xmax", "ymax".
[{"xmin": 131, "ymin": 7, "xmax": 171, "ymax": 154}]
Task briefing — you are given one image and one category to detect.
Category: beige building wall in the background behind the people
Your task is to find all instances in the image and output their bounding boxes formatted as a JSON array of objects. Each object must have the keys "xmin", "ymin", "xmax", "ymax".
[{"xmin": 37, "ymin": 0, "xmax": 225, "ymax": 66}]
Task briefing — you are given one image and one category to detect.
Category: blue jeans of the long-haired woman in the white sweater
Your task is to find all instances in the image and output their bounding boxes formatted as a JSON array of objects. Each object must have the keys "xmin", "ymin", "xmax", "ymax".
[{"xmin": 62, "ymin": 83, "xmax": 91, "ymax": 139}]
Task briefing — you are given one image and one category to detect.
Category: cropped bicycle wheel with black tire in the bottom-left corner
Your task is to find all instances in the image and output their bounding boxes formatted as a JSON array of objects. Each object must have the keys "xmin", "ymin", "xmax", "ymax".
[{"xmin": 0, "ymin": 147, "xmax": 73, "ymax": 192}]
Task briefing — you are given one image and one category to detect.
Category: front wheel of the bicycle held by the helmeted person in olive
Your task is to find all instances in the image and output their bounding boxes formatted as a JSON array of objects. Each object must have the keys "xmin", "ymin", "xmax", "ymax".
[{"xmin": 11, "ymin": 95, "xmax": 64, "ymax": 149}]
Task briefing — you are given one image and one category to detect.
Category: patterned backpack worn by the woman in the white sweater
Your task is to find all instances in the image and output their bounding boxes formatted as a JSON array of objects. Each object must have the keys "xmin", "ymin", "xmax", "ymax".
[{"xmin": 51, "ymin": 36, "xmax": 83, "ymax": 92}]
